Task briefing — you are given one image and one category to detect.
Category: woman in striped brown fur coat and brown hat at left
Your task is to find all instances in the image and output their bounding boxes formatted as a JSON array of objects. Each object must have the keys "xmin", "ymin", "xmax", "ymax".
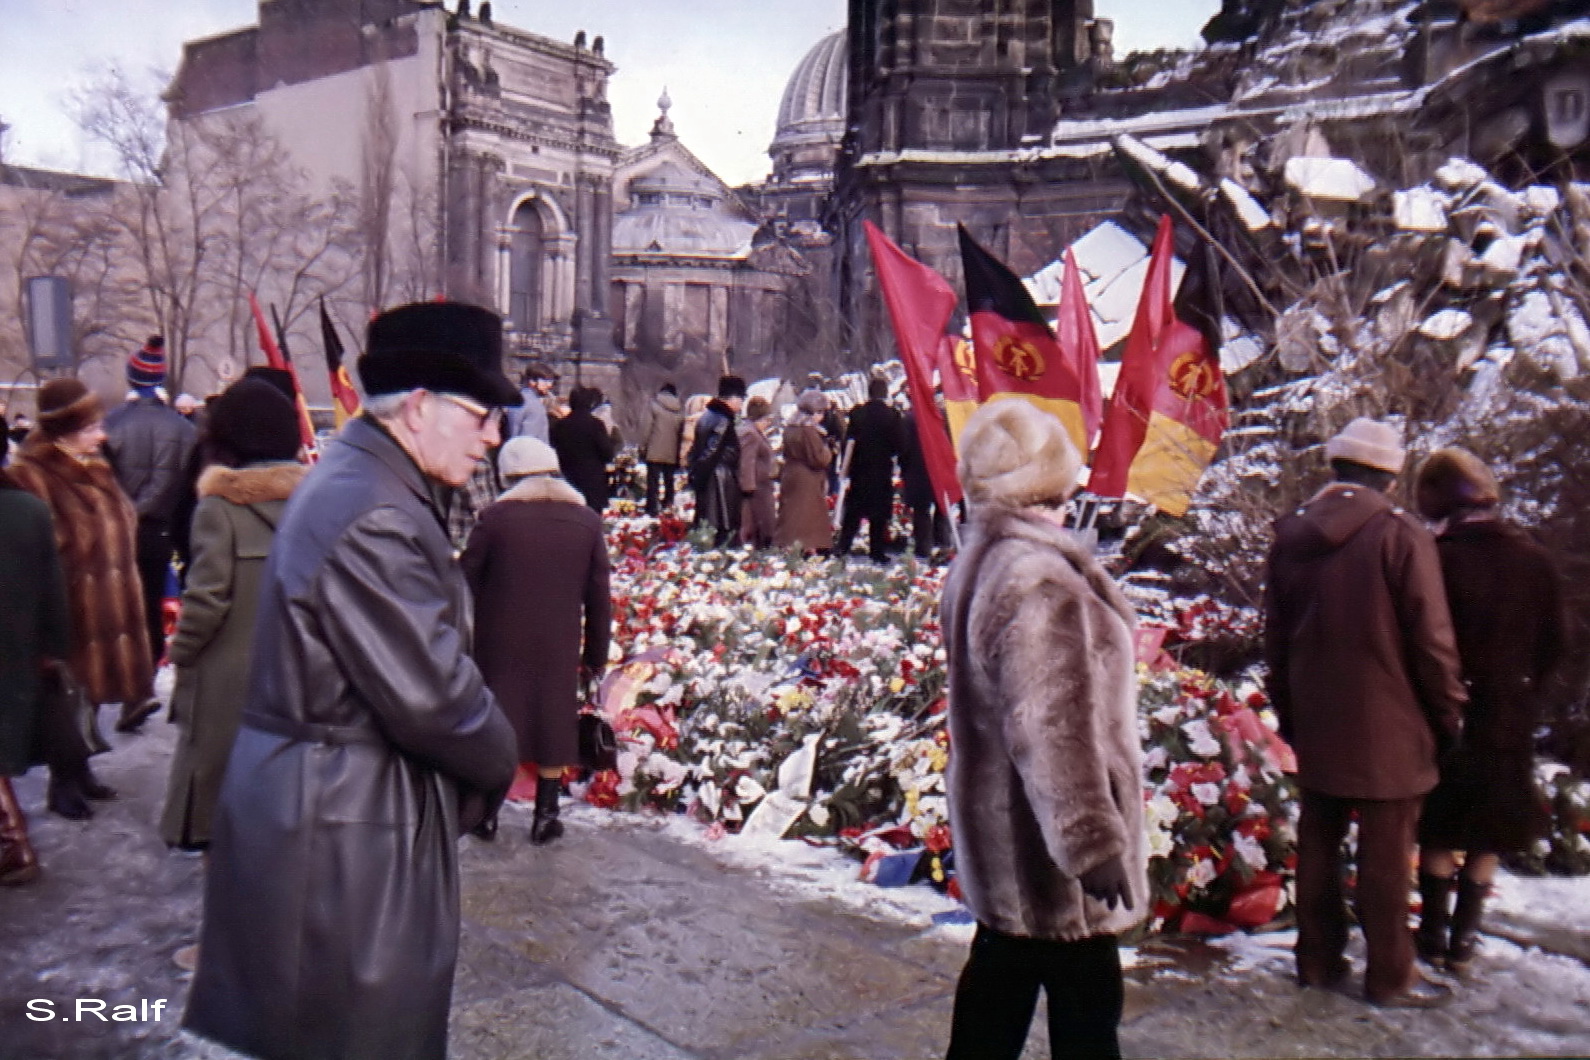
[{"xmin": 11, "ymin": 378, "xmax": 157, "ymax": 820}]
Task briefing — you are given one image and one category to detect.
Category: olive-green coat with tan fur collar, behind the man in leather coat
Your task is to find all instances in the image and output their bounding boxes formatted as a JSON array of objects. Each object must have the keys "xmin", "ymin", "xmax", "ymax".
[{"xmin": 161, "ymin": 464, "xmax": 308, "ymax": 847}]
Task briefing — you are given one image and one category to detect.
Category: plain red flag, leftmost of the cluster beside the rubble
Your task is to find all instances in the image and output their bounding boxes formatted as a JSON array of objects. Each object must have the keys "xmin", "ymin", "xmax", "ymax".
[{"xmin": 863, "ymin": 221, "xmax": 960, "ymax": 512}]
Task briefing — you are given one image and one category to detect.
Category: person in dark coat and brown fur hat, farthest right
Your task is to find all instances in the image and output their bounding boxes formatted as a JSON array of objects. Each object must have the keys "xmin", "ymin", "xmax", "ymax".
[{"xmin": 1414, "ymin": 448, "xmax": 1565, "ymax": 973}]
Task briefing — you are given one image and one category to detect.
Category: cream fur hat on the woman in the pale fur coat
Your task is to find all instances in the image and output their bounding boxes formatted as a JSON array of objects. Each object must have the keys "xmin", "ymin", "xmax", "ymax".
[{"xmin": 957, "ymin": 397, "xmax": 1083, "ymax": 509}]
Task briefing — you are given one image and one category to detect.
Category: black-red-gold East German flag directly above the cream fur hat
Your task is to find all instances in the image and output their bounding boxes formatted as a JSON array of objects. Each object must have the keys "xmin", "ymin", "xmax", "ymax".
[{"xmin": 957, "ymin": 226, "xmax": 1097, "ymax": 456}]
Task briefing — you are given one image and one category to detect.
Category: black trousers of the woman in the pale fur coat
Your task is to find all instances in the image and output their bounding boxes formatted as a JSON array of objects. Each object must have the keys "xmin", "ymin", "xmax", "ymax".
[{"xmin": 946, "ymin": 923, "xmax": 1126, "ymax": 1060}]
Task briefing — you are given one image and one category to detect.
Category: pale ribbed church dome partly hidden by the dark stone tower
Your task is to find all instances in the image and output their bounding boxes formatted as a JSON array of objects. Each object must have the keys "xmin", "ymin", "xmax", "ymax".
[{"xmin": 768, "ymin": 30, "xmax": 849, "ymax": 183}]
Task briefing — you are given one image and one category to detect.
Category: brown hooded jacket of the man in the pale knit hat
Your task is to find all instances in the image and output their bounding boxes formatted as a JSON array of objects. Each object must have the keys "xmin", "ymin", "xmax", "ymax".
[{"xmin": 1264, "ymin": 483, "xmax": 1466, "ymax": 799}]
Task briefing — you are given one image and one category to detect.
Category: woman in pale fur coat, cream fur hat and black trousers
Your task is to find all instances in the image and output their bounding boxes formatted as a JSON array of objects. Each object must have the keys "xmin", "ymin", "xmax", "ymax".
[{"xmin": 941, "ymin": 400, "xmax": 1148, "ymax": 1060}]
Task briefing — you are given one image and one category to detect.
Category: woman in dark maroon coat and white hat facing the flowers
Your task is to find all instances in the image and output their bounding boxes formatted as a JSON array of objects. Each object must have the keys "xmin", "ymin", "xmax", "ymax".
[{"xmin": 460, "ymin": 435, "xmax": 612, "ymax": 844}]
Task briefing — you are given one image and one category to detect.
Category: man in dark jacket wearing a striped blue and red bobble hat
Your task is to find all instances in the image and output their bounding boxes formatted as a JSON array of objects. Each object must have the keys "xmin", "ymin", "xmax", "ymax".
[{"xmin": 105, "ymin": 335, "xmax": 199, "ymax": 733}]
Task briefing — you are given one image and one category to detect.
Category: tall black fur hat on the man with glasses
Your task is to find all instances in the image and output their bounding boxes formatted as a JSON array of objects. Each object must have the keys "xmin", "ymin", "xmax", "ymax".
[{"xmin": 359, "ymin": 302, "xmax": 525, "ymax": 407}]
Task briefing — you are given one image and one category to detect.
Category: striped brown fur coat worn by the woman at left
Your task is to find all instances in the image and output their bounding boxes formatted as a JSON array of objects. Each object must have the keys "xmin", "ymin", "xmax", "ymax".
[{"xmin": 10, "ymin": 431, "xmax": 154, "ymax": 702}]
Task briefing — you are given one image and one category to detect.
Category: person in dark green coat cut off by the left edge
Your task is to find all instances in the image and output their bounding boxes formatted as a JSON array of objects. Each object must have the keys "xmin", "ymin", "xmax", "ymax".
[{"xmin": 0, "ymin": 469, "xmax": 68, "ymax": 887}]
